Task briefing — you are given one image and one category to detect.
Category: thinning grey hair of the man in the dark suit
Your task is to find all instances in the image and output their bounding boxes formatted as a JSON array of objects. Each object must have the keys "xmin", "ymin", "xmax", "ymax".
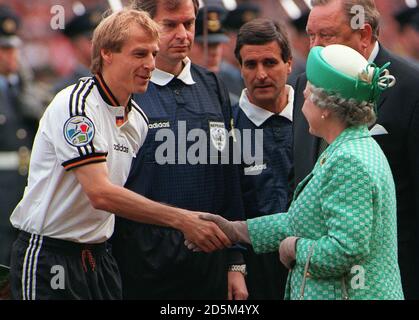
[{"xmin": 311, "ymin": 0, "xmax": 380, "ymax": 41}]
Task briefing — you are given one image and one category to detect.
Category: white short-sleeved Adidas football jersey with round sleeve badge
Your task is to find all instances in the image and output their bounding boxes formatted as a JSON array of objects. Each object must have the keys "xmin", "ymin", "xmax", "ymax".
[{"xmin": 10, "ymin": 77, "xmax": 148, "ymax": 243}]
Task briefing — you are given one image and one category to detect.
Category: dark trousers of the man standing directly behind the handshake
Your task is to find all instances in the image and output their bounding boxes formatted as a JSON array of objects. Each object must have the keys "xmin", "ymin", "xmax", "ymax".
[{"xmin": 111, "ymin": 219, "xmax": 228, "ymax": 300}]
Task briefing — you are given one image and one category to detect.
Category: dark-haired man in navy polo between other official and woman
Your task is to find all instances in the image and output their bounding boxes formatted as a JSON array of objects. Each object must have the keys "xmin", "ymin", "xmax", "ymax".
[{"xmin": 233, "ymin": 19, "xmax": 294, "ymax": 299}]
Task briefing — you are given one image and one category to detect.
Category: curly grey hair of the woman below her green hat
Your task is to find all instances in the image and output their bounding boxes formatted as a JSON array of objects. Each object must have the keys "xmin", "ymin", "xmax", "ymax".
[{"xmin": 309, "ymin": 85, "xmax": 376, "ymax": 127}]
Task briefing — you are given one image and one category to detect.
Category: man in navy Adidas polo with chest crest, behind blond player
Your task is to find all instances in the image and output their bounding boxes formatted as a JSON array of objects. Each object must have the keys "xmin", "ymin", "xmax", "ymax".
[{"xmin": 113, "ymin": 0, "xmax": 247, "ymax": 299}]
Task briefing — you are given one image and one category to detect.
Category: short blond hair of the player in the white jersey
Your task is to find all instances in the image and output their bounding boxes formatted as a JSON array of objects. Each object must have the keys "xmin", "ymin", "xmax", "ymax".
[{"xmin": 90, "ymin": 8, "xmax": 159, "ymax": 74}]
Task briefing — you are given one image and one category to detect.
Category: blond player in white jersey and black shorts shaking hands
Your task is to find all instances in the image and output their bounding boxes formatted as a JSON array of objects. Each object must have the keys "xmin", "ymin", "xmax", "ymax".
[{"xmin": 10, "ymin": 9, "xmax": 230, "ymax": 299}]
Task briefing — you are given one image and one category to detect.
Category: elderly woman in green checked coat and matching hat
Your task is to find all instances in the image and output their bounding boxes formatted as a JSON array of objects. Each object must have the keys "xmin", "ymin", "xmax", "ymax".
[{"xmin": 186, "ymin": 45, "xmax": 403, "ymax": 299}]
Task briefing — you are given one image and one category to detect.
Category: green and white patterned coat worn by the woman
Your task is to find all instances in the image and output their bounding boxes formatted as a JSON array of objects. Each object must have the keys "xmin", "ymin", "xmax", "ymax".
[{"xmin": 248, "ymin": 126, "xmax": 403, "ymax": 299}]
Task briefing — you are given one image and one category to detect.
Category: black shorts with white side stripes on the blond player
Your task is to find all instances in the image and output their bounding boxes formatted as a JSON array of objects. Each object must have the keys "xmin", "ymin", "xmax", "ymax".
[{"xmin": 10, "ymin": 231, "xmax": 122, "ymax": 300}]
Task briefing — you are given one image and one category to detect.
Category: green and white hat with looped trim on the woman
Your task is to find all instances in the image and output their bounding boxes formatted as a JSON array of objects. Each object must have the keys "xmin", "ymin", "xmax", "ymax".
[{"xmin": 306, "ymin": 44, "xmax": 396, "ymax": 103}]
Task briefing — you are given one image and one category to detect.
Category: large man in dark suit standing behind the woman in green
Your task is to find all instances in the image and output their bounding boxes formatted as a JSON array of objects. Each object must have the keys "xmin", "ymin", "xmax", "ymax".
[{"xmin": 294, "ymin": 0, "xmax": 419, "ymax": 299}]
